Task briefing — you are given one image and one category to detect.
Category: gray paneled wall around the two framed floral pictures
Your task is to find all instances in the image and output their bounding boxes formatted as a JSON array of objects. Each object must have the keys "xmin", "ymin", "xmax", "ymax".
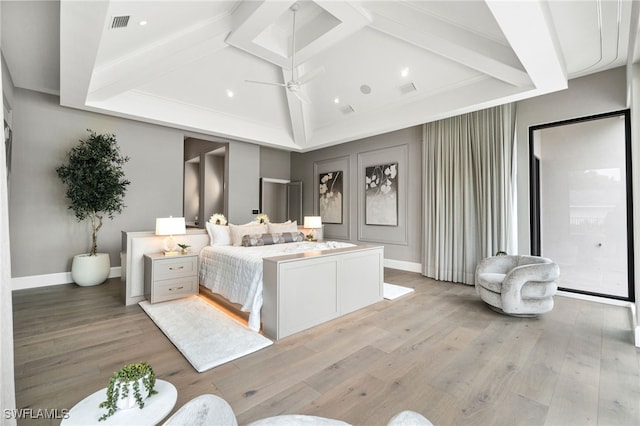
[{"xmin": 291, "ymin": 126, "xmax": 422, "ymax": 263}]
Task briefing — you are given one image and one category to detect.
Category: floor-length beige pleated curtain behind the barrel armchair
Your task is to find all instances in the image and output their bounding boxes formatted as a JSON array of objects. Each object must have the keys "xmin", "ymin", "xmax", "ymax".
[{"xmin": 422, "ymin": 104, "xmax": 515, "ymax": 284}]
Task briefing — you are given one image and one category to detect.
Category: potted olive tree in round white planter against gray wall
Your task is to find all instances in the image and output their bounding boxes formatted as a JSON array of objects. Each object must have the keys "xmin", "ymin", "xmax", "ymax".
[{"xmin": 56, "ymin": 130, "xmax": 130, "ymax": 286}]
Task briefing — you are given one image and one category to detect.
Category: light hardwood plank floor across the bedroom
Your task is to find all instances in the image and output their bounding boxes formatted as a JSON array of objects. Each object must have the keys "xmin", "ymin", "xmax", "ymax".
[{"xmin": 13, "ymin": 269, "xmax": 640, "ymax": 425}]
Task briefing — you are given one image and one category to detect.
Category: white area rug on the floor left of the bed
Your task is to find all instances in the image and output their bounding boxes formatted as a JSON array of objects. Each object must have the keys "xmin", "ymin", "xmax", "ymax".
[{"xmin": 139, "ymin": 296, "xmax": 273, "ymax": 373}]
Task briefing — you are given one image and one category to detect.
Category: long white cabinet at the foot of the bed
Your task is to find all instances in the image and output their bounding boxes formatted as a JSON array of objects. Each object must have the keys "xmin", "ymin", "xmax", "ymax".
[{"xmin": 262, "ymin": 246, "xmax": 384, "ymax": 339}]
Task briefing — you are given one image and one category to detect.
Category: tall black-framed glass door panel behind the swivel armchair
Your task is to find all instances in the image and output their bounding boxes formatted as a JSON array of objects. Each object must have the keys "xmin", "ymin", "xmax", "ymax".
[{"xmin": 529, "ymin": 110, "xmax": 634, "ymax": 301}]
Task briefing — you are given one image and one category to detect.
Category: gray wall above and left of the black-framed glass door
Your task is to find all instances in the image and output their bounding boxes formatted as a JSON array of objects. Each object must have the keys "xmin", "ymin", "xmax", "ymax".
[{"xmin": 516, "ymin": 67, "xmax": 627, "ymax": 254}]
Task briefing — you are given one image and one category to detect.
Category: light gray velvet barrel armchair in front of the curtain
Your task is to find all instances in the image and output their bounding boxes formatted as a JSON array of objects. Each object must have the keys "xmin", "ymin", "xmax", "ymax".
[{"xmin": 475, "ymin": 255, "xmax": 560, "ymax": 316}]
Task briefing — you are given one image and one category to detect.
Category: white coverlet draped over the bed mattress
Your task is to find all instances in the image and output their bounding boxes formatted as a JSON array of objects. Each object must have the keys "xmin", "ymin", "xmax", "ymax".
[{"xmin": 199, "ymin": 241, "xmax": 353, "ymax": 331}]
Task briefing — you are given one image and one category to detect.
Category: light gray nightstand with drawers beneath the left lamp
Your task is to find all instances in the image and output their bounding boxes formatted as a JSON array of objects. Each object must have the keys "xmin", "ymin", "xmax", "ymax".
[{"xmin": 144, "ymin": 253, "xmax": 198, "ymax": 303}]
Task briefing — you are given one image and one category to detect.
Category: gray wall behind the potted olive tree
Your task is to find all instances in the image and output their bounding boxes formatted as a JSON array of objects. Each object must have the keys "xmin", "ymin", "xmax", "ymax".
[{"xmin": 9, "ymin": 89, "xmax": 183, "ymax": 277}]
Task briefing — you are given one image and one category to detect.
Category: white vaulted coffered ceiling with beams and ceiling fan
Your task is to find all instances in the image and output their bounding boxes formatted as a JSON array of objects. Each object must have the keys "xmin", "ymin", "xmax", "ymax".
[{"xmin": 2, "ymin": 0, "xmax": 638, "ymax": 151}]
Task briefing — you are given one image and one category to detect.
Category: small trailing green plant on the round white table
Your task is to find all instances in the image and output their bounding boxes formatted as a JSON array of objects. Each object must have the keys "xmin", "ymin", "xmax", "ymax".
[{"xmin": 98, "ymin": 362, "xmax": 158, "ymax": 421}]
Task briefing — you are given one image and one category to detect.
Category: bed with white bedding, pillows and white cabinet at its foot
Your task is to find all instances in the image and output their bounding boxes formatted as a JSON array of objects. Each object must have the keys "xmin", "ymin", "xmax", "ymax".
[{"xmin": 199, "ymin": 225, "xmax": 384, "ymax": 339}]
